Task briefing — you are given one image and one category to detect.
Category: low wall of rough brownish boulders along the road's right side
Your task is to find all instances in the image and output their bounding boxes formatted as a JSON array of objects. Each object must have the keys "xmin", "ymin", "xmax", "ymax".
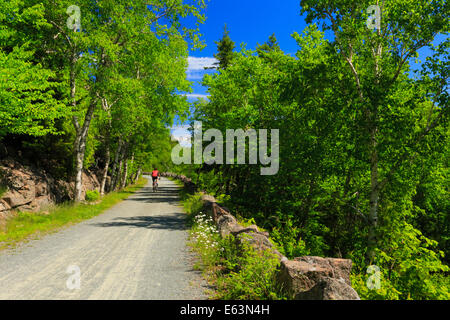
[{"xmin": 161, "ymin": 173, "xmax": 359, "ymax": 300}]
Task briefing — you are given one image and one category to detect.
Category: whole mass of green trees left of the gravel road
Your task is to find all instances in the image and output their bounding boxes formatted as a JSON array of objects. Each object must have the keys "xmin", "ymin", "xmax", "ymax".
[{"xmin": 0, "ymin": 0, "xmax": 206, "ymax": 200}]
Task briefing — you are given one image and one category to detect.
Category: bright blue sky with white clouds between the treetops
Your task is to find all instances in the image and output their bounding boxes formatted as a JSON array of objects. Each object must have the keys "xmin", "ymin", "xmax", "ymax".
[{"xmin": 172, "ymin": 0, "xmax": 444, "ymax": 145}]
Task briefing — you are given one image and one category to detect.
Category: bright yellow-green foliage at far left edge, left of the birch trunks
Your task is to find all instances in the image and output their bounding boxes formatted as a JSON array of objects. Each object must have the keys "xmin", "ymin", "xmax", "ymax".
[{"xmin": 0, "ymin": 0, "xmax": 69, "ymax": 139}]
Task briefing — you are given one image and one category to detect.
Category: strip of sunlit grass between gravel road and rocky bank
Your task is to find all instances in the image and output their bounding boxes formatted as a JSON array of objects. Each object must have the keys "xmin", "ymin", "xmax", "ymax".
[{"xmin": 0, "ymin": 178, "xmax": 147, "ymax": 250}]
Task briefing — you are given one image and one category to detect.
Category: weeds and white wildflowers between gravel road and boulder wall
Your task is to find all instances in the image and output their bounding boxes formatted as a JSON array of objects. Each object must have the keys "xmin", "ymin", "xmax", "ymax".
[{"xmin": 182, "ymin": 192, "xmax": 287, "ymax": 300}]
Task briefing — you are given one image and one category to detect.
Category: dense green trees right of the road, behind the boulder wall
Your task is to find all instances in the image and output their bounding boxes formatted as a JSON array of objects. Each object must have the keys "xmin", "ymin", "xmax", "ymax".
[{"xmin": 185, "ymin": 0, "xmax": 450, "ymax": 299}]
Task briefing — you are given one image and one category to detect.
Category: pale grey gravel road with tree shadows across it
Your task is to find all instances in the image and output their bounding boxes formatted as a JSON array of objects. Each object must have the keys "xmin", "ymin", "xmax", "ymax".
[{"xmin": 0, "ymin": 178, "xmax": 206, "ymax": 300}]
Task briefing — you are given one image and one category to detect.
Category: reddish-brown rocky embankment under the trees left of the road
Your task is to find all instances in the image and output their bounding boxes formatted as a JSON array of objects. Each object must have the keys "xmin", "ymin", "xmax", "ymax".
[{"xmin": 0, "ymin": 160, "xmax": 100, "ymax": 219}]
